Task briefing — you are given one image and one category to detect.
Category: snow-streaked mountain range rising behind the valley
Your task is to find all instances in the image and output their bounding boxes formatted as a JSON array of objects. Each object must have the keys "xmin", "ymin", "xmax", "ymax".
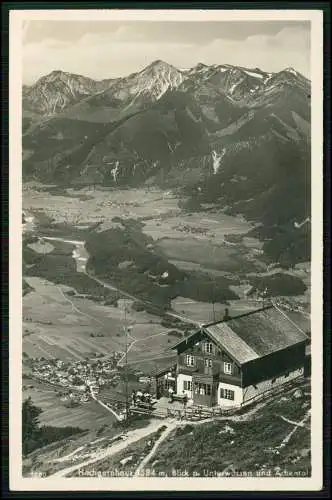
[{"xmin": 22, "ymin": 60, "xmax": 311, "ymax": 266}]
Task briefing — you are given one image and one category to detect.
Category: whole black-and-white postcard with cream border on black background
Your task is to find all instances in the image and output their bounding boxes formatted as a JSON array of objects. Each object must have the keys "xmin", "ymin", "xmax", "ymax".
[{"xmin": 10, "ymin": 10, "xmax": 323, "ymax": 491}]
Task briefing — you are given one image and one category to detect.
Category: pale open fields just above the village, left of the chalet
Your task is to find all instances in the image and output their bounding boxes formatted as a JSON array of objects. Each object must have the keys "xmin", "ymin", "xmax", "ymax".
[{"xmin": 23, "ymin": 277, "xmax": 178, "ymax": 361}]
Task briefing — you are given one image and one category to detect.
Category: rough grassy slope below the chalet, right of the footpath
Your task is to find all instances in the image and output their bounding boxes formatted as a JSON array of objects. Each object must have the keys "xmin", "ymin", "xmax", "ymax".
[{"xmin": 149, "ymin": 390, "xmax": 310, "ymax": 475}]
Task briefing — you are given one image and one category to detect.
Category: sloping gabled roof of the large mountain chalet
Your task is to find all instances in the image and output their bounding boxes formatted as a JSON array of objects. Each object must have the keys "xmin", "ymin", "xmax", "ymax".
[{"xmin": 173, "ymin": 305, "xmax": 308, "ymax": 364}]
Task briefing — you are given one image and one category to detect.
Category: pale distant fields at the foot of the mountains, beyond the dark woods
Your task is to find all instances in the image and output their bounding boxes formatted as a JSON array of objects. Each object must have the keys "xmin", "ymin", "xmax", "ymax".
[{"xmin": 23, "ymin": 184, "xmax": 261, "ymax": 271}]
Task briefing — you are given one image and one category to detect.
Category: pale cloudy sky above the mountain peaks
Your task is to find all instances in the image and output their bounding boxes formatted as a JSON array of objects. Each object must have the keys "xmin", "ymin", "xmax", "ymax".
[{"xmin": 23, "ymin": 21, "xmax": 310, "ymax": 84}]
